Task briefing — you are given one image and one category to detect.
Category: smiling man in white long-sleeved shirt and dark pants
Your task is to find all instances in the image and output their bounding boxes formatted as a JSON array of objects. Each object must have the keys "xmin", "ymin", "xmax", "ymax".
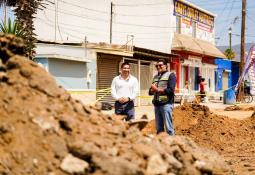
[{"xmin": 111, "ymin": 62, "xmax": 138, "ymax": 121}]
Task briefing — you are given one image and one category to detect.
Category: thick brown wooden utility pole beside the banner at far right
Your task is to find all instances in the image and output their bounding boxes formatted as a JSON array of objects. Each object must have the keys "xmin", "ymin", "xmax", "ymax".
[{"xmin": 237, "ymin": 0, "xmax": 246, "ymax": 100}]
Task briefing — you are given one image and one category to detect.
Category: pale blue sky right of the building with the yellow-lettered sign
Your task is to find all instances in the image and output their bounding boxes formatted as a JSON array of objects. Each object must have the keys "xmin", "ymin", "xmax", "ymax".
[{"xmin": 0, "ymin": 0, "xmax": 255, "ymax": 46}]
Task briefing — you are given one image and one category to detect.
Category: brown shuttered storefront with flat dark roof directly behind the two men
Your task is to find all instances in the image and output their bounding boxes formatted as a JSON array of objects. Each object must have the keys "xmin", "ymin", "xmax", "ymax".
[{"xmin": 96, "ymin": 47, "xmax": 176, "ymax": 106}]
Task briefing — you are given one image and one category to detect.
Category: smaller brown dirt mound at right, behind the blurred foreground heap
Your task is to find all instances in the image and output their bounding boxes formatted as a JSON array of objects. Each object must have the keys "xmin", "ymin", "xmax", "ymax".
[{"xmin": 143, "ymin": 104, "xmax": 255, "ymax": 174}]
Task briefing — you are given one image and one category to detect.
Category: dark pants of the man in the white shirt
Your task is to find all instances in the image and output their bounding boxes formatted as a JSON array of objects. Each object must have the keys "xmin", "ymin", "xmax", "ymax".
[{"xmin": 114, "ymin": 101, "xmax": 135, "ymax": 121}]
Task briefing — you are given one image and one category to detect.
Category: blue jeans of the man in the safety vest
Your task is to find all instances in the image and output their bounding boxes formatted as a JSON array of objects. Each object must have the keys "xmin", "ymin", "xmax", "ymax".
[{"xmin": 155, "ymin": 104, "xmax": 174, "ymax": 135}]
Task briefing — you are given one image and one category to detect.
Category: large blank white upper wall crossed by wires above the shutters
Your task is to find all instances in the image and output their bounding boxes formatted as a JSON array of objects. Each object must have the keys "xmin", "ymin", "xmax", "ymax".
[{"xmin": 35, "ymin": 0, "xmax": 176, "ymax": 53}]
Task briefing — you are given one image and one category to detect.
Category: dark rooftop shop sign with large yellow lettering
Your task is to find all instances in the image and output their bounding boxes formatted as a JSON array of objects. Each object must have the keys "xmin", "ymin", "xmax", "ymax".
[{"xmin": 174, "ymin": 0, "xmax": 214, "ymax": 27}]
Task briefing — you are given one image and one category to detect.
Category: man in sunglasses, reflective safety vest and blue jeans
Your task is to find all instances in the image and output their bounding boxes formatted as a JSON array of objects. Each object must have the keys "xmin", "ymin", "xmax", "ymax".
[{"xmin": 149, "ymin": 60, "xmax": 176, "ymax": 135}]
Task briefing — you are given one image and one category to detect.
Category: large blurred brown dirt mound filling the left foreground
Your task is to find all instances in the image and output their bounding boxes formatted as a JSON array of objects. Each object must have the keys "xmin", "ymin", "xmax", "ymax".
[{"xmin": 0, "ymin": 36, "xmax": 231, "ymax": 175}]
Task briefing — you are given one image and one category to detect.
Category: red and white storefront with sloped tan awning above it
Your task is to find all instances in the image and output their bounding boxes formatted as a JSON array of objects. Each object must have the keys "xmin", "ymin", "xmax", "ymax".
[{"xmin": 172, "ymin": 33, "xmax": 225, "ymax": 92}]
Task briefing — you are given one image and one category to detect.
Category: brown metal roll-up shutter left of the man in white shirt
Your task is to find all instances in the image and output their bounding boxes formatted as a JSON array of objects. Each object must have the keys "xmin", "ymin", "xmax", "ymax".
[{"xmin": 96, "ymin": 54, "xmax": 121, "ymax": 105}]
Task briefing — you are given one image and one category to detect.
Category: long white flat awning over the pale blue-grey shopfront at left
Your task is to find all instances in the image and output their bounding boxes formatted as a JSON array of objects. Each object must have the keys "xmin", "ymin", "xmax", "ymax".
[{"xmin": 35, "ymin": 54, "xmax": 91, "ymax": 63}]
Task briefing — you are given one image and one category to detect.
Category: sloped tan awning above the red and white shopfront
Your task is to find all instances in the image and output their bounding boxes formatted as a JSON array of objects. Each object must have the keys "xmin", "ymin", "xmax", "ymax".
[{"xmin": 172, "ymin": 33, "xmax": 226, "ymax": 58}]
